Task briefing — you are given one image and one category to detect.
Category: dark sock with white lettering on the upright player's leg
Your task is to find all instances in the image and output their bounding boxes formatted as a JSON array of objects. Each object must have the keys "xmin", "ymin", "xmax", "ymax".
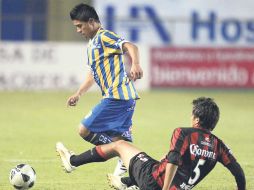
[{"xmin": 84, "ymin": 132, "xmax": 112, "ymax": 145}]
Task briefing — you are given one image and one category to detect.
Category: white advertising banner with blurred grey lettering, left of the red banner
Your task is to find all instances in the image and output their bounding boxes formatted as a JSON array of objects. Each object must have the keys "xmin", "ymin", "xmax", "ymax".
[{"xmin": 0, "ymin": 42, "xmax": 149, "ymax": 90}]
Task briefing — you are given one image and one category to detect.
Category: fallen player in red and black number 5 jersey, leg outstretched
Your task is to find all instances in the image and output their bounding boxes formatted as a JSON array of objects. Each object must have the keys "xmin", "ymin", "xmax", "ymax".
[{"xmin": 58, "ymin": 97, "xmax": 246, "ymax": 190}]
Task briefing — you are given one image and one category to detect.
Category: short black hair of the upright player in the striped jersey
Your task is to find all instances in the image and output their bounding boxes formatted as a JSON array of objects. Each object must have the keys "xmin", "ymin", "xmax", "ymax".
[{"xmin": 70, "ymin": 3, "xmax": 100, "ymax": 22}]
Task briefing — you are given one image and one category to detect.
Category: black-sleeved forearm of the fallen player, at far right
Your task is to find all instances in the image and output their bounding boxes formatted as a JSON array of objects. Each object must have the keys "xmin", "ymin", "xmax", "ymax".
[{"xmin": 226, "ymin": 162, "xmax": 246, "ymax": 190}]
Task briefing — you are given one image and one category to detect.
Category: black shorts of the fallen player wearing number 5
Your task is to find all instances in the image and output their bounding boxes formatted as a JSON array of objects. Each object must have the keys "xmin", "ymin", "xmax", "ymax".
[{"xmin": 129, "ymin": 152, "xmax": 161, "ymax": 190}]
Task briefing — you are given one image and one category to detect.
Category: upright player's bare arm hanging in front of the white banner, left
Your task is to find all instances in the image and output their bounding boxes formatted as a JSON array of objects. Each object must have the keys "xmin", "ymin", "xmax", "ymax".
[{"xmin": 67, "ymin": 72, "xmax": 94, "ymax": 106}]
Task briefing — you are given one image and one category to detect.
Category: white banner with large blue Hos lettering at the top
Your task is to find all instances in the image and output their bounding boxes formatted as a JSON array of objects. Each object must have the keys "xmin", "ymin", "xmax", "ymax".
[{"xmin": 94, "ymin": 0, "xmax": 254, "ymax": 47}]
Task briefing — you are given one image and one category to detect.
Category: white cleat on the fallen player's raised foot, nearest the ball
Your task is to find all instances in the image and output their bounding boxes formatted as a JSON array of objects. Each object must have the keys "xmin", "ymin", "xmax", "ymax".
[{"xmin": 56, "ymin": 142, "xmax": 76, "ymax": 173}]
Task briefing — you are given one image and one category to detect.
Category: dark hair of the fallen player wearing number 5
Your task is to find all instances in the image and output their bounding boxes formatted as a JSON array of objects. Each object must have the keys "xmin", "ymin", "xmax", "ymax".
[{"xmin": 192, "ymin": 97, "xmax": 220, "ymax": 130}]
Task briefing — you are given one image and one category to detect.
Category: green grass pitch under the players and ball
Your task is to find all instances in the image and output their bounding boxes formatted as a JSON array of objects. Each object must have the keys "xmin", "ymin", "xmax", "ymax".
[{"xmin": 0, "ymin": 89, "xmax": 254, "ymax": 190}]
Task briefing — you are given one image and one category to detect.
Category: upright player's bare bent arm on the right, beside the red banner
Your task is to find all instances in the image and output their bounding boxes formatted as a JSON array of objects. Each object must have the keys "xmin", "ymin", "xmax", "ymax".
[{"xmin": 123, "ymin": 42, "xmax": 143, "ymax": 81}]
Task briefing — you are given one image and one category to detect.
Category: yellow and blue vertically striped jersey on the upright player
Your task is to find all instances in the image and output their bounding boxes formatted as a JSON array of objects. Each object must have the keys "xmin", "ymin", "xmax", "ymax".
[{"xmin": 87, "ymin": 28, "xmax": 139, "ymax": 100}]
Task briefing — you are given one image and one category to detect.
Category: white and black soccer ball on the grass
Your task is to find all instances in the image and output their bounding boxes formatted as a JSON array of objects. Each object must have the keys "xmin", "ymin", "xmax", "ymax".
[{"xmin": 9, "ymin": 164, "xmax": 36, "ymax": 190}]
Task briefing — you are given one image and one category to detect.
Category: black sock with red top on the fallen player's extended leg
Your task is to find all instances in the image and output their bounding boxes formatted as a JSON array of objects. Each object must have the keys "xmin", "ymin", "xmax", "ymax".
[{"xmin": 70, "ymin": 147, "xmax": 107, "ymax": 166}]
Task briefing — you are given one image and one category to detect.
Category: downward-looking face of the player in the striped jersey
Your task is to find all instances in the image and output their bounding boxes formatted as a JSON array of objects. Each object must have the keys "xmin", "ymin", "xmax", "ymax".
[{"xmin": 72, "ymin": 20, "xmax": 94, "ymax": 39}]
